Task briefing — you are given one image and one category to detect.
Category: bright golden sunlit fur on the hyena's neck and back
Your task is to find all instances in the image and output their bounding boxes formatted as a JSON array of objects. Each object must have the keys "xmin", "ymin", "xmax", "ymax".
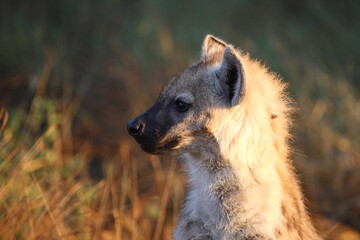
[{"xmin": 205, "ymin": 56, "xmax": 315, "ymax": 239}]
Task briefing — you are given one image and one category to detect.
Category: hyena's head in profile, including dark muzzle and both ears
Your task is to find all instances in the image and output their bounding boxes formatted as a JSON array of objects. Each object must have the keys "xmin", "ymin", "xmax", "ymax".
[{"xmin": 127, "ymin": 35, "xmax": 246, "ymax": 155}]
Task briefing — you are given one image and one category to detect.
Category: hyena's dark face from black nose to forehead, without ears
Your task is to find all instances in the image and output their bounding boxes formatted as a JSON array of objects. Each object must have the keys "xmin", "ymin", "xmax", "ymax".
[{"xmin": 127, "ymin": 63, "xmax": 209, "ymax": 154}]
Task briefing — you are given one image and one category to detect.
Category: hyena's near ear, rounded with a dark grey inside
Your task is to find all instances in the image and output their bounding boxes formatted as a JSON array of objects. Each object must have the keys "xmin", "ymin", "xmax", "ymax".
[{"xmin": 215, "ymin": 46, "xmax": 246, "ymax": 107}]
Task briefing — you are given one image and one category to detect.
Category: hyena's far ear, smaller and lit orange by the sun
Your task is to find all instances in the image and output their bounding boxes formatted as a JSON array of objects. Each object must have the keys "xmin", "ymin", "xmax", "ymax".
[{"xmin": 201, "ymin": 35, "xmax": 226, "ymax": 61}]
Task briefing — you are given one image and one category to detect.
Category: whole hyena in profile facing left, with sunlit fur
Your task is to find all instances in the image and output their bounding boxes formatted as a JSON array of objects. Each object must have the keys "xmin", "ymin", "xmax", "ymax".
[{"xmin": 128, "ymin": 35, "xmax": 318, "ymax": 240}]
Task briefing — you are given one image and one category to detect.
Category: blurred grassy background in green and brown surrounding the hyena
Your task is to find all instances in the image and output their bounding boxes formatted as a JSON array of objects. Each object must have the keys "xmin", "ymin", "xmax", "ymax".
[{"xmin": 0, "ymin": 0, "xmax": 360, "ymax": 239}]
